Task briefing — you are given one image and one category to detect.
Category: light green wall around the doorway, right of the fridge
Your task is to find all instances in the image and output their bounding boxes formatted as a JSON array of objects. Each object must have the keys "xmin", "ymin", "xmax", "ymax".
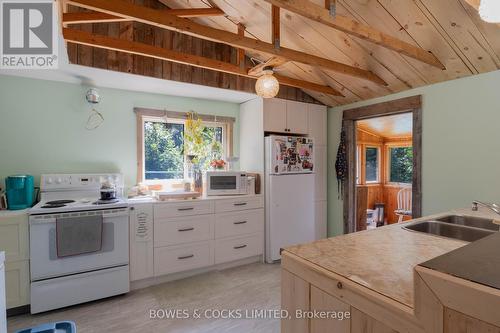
[{"xmin": 328, "ymin": 71, "xmax": 500, "ymax": 235}]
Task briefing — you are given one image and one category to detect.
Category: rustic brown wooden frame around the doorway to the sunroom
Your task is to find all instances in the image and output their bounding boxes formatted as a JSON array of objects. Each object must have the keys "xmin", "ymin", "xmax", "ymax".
[{"xmin": 342, "ymin": 95, "xmax": 422, "ymax": 233}]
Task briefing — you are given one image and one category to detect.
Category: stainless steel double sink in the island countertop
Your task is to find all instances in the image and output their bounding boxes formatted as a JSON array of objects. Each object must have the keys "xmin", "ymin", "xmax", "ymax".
[{"xmin": 403, "ymin": 215, "xmax": 500, "ymax": 242}]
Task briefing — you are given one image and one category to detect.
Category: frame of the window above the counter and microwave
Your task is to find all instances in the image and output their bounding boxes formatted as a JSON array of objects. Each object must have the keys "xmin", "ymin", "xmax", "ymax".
[{"xmin": 134, "ymin": 108, "xmax": 236, "ymax": 187}]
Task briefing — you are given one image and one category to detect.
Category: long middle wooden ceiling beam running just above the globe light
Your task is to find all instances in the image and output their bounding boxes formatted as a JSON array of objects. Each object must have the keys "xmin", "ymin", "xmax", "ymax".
[{"xmin": 68, "ymin": 0, "xmax": 387, "ymax": 86}]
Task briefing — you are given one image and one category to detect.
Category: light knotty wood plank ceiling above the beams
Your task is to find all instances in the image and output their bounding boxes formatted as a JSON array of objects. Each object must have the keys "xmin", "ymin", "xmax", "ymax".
[{"xmin": 61, "ymin": 0, "xmax": 500, "ymax": 106}]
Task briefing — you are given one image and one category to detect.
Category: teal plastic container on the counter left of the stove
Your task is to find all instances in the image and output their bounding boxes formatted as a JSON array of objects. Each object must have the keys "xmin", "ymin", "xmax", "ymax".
[{"xmin": 5, "ymin": 175, "xmax": 35, "ymax": 210}]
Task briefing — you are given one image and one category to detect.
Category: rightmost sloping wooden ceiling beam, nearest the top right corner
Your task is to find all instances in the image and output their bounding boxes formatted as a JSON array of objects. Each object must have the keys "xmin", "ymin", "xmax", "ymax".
[{"xmin": 265, "ymin": 0, "xmax": 448, "ymax": 70}]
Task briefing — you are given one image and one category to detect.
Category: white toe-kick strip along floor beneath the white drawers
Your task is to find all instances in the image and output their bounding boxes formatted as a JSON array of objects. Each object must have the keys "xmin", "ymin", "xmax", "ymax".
[{"xmin": 130, "ymin": 255, "xmax": 263, "ymax": 290}]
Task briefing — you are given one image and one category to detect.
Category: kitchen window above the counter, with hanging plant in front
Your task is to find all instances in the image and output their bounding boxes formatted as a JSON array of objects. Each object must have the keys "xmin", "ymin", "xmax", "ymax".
[{"xmin": 135, "ymin": 109, "xmax": 234, "ymax": 185}]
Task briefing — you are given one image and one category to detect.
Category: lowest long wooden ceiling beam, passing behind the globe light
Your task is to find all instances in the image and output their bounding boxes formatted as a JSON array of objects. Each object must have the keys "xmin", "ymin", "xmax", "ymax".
[{"xmin": 63, "ymin": 28, "xmax": 343, "ymax": 96}]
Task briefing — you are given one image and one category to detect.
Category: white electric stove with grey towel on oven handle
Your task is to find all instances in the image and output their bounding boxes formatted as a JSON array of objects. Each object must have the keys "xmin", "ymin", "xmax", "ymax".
[{"xmin": 29, "ymin": 174, "xmax": 130, "ymax": 313}]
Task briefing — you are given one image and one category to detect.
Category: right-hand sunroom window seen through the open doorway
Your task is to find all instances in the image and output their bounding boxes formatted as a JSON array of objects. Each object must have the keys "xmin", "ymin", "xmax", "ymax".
[{"xmin": 388, "ymin": 146, "xmax": 413, "ymax": 184}]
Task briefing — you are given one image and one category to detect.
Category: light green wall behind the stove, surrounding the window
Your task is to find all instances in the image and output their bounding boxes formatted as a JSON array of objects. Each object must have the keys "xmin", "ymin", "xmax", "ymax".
[{"xmin": 0, "ymin": 75, "xmax": 239, "ymax": 188}]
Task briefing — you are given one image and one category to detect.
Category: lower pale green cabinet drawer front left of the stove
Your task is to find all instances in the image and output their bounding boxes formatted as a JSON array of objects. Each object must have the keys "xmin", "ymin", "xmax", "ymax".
[{"xmin": 5, "ymin": 260, "xmax": 30, "ymax": 309}]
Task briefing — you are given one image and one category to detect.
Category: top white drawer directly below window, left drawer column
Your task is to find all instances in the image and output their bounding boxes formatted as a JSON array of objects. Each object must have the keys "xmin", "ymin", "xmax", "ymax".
[{"xmin": 154, "ymin": 200, "xmax": 214, "ymax": 219}]
